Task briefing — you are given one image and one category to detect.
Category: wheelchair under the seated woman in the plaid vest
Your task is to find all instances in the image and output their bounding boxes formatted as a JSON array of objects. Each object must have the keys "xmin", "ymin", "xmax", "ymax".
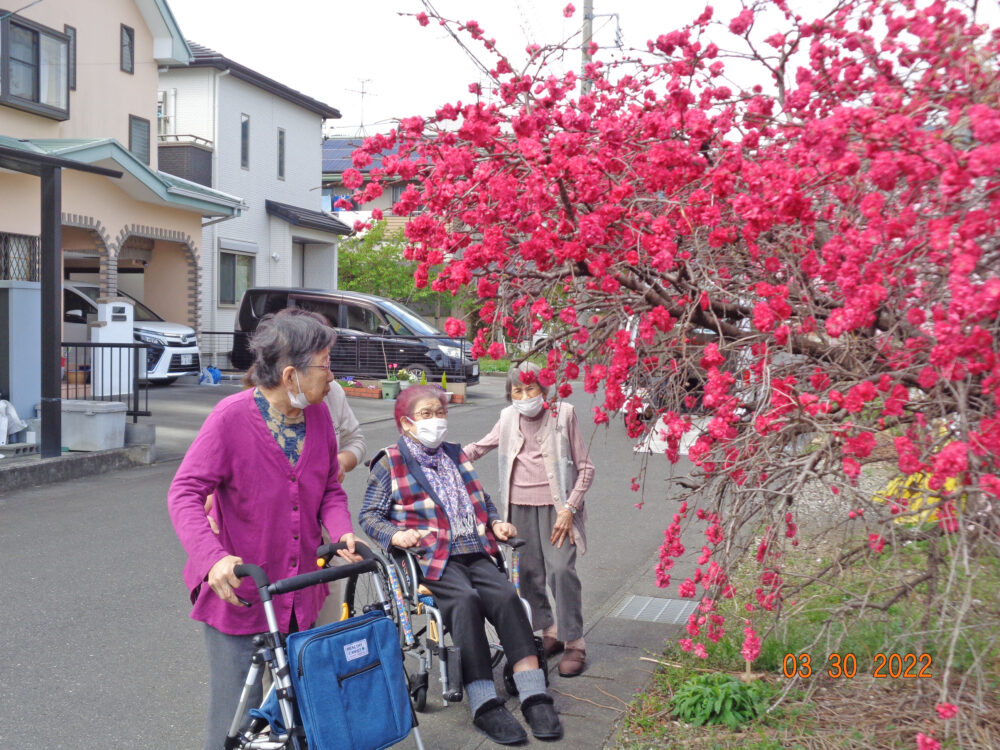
[{"xmin": 341, "ymin": 537, "xmax": 549, "ymax": 712}]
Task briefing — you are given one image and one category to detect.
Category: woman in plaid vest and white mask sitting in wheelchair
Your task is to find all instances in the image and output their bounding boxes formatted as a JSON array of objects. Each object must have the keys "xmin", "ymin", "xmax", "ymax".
[{"xmin": 359, "ymin": 386, "xmax": 562, "ymax": 745}]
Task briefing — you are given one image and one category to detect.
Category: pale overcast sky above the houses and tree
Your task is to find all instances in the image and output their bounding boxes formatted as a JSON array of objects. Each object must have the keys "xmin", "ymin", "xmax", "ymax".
[{"xmin": 168, "ymin": 0, "xmax": 998, "ymax": 135}]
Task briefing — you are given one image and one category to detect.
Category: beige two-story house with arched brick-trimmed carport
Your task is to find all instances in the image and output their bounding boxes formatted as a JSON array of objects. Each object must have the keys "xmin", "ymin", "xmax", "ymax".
[{"xmin": 0, "ymin": 0, "xmax": 243, "ymax": 329}]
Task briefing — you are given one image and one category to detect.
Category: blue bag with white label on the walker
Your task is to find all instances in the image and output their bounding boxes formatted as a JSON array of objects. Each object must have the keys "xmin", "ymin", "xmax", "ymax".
[{"xmin": 287, "ymin": 612, "xmax": 413, "ymax": 750}]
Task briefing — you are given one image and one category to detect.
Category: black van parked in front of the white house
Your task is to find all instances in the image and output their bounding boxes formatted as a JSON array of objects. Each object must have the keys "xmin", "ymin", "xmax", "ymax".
[{"xmin": 236, "ymin": 287, "xmax": 479, "ymax": 385}]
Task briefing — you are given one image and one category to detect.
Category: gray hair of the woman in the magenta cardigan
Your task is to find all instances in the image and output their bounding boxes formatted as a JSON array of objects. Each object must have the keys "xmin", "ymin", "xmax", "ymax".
[{"xmin": 250, "ymin": 308, "xmax": 337, "ymax": 388}]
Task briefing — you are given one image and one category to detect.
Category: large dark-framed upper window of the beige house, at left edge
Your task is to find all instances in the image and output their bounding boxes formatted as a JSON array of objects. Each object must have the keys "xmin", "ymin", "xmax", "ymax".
[{"xmin": 0, "ymin": 14, "xmax": 70, "ymax": 120}]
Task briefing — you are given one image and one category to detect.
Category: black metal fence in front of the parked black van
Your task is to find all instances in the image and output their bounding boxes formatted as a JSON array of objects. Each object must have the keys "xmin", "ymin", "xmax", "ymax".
[{"xmin": 200, "ymin": 329, "xmax": 479, "ymax": 383}]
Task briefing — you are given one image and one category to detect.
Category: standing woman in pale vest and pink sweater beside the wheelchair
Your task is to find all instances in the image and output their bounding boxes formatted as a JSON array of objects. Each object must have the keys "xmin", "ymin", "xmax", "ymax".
[{"xmin": 464, "ymin": 362, "xmax": 594, "ymax": 677}]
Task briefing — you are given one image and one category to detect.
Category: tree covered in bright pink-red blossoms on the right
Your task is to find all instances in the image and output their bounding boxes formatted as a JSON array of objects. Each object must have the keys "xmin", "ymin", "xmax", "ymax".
[{"xmin": 344, "ymin": 0, "xmax": 1000, "ymax": 724}]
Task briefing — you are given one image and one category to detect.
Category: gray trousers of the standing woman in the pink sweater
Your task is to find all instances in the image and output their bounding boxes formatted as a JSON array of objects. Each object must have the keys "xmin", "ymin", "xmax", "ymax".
[{"xmin": 510, "ymin": 505, "xmax": 583, "ymax": 641}]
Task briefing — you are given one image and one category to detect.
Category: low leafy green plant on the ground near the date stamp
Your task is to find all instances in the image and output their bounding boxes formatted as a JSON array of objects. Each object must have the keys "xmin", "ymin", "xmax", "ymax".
[{"xmin": 670, "ymin": 672, "xmax": 771, "ymax": 729}]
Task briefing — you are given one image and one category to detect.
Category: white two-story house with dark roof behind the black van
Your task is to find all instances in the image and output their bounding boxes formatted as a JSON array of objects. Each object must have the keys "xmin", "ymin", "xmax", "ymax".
[{"xmin": 158, "ymin": 42, "xmax": 352, "ymax": 351}]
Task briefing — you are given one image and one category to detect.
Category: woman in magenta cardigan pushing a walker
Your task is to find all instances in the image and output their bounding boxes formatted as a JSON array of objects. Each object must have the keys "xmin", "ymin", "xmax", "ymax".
[{"xmin": 167, "ymin": 312, "xmax": 359, "ymax": 748}]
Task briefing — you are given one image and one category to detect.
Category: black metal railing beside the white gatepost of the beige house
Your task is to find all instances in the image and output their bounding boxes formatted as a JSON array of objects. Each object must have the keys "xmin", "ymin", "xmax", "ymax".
[{"xmin": 61, "ymin": 342, "xmax": 151, "ymax": 422}]
